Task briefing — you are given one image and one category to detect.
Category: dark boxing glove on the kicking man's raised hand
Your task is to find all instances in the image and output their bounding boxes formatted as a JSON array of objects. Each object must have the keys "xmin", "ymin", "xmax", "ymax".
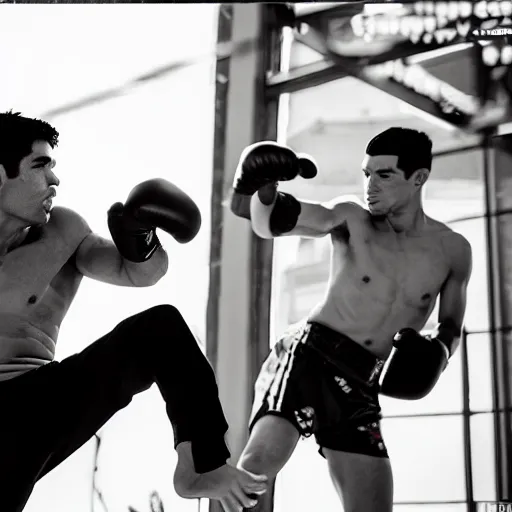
[{"xmin": 108, "ymin": 178, "xmax": 201, "ymax": 263}]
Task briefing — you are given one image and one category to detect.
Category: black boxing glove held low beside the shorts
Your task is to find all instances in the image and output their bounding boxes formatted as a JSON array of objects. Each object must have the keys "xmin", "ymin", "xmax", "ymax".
[{"xmin": 380, "ymin": 328, "xmax": 450, "ymax": 400}]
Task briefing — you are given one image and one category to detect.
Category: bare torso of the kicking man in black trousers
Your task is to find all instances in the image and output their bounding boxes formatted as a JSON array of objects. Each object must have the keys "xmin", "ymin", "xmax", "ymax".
[{"xmin": 0, "ymin": 207, "xmax": 89, "ymax": 381}]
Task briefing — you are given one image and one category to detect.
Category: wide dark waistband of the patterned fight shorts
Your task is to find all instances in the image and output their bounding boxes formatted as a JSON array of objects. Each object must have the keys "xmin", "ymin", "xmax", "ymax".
[{"xmin": 305, "ymin": 322, "xmax": 384, "ymax": 385}]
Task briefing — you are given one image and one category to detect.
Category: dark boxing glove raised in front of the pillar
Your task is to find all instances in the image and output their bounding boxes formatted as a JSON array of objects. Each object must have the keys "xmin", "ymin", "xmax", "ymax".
[{"xmin": 233, "ymin": 141, "xmax": 317, "ymax": 196}]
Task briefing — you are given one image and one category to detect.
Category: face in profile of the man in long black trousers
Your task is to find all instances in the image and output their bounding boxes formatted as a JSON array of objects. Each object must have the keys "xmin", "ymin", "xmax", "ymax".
[{"xmin": 0, "ymin": 141, "xmax": 59, "ymax": 226}]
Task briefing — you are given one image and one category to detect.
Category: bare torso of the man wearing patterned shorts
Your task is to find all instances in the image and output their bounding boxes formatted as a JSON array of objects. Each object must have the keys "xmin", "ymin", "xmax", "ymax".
[{"xmin": 309, "ymin": 202, "xmax": 460, "ymax": 358}]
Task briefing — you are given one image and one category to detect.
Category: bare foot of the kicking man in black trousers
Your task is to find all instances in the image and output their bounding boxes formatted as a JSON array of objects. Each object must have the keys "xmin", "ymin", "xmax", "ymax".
[{"xmin": 174, "ymin": 443, "xmax": 267, "ymax": 508}]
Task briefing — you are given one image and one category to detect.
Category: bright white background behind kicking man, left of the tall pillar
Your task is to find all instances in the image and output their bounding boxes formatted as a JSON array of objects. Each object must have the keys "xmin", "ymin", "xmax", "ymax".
[{"xmin": 0, "ymin": 4, "xmax": 217, "ymax": 512}]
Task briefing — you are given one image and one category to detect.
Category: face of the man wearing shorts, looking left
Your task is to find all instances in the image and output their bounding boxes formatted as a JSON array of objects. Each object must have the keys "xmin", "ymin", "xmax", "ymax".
[{"xmin": 362, "ymin": 155, "xmax": 423, "ymax": 216}]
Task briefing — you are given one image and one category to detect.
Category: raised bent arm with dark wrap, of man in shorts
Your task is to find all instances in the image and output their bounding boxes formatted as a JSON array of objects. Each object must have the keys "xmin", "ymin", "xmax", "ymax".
[{"xmin": 251, "ymin": 187, "xmax": 364, "ymax": 238}]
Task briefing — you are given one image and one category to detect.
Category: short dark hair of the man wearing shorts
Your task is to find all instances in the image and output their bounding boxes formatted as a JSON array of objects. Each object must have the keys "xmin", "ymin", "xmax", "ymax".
[{"xmin": 366, "ymin": 127, "xmax": 432, "ymax": 179}]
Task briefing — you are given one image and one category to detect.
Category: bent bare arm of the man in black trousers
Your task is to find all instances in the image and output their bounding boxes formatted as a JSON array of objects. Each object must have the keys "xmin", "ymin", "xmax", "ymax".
[{"xmin": 75, "ymin": 233, "xmax": 168, "ymax": 287}]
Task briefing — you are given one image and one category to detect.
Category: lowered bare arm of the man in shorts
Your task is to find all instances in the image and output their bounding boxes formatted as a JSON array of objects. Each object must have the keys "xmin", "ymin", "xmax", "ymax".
[{"xmin": 431, "ymin": 234, "xmax": 473, "ymax": 355}]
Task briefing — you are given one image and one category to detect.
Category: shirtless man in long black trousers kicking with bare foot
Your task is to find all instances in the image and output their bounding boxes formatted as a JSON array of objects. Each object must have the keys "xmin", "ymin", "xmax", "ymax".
[{"xmin": 0, "ymin": 112, "xmax": 266, "ymax": 512}]
